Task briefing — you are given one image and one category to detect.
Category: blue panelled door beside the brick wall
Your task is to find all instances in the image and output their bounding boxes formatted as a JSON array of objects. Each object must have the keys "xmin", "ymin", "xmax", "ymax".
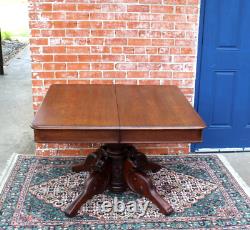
[{"xmin": 193, "ymin": 0, "xmax": 250, "ymax": 150}]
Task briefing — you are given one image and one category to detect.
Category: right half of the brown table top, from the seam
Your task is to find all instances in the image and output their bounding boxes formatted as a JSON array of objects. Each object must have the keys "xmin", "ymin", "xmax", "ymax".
[{"xmin": 116, "ymin": 85, "xmax": 204, "ymax": 130}]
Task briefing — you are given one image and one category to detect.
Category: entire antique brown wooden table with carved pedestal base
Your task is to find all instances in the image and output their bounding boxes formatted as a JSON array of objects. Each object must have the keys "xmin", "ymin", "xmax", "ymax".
[{"xmin": 32, "ymin": 85, "xmax": 205, "ymax": 217}]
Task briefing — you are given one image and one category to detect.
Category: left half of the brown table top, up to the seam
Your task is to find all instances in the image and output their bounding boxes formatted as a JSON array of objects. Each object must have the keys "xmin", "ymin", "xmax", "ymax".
[{"xmin": 32, "ymin": 84, "xmax": 119, "ymax": 132}]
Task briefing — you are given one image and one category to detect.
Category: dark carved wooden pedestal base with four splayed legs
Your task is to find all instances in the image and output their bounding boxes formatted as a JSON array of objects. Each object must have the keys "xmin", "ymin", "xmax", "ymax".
[{"xmin": 65, "ymin": 144, "xmax": 173, "ymax": 217}]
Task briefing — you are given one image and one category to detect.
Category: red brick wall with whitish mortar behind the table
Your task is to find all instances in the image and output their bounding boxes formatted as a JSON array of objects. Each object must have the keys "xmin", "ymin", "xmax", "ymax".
[{"xmin": 29, "ymin": 0, "xmax": 199, "ymax": 155}]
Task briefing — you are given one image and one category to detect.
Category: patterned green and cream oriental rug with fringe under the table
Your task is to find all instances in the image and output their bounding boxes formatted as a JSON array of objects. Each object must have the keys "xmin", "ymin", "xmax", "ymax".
[{"xmin": 0, "ymin": 155, "xmax": 250, "ymax": 230}]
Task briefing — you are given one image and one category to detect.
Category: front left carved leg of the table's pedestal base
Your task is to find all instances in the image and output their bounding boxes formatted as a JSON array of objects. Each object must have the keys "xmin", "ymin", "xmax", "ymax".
[{"xmin": 64, "ymin": 164, "xmax": 110, "ymax": 217}]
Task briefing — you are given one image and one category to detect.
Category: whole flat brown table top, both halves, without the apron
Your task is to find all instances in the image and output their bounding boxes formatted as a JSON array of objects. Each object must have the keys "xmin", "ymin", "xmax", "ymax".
[{"xmin": 32, "ymin": 84, "xmax": 205, "ymax": 142}]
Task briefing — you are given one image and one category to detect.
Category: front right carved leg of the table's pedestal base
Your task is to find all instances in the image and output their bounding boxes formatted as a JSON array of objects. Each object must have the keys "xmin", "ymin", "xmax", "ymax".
[{"xmin": 124, "ymin": 160, "xmax": 174, "ymax": 215}]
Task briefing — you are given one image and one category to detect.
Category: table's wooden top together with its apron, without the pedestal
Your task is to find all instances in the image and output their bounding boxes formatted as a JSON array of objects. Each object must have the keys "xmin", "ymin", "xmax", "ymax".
[{"xmin": 32, "ymin": 85, "xmax": 205, "ymax": 143}]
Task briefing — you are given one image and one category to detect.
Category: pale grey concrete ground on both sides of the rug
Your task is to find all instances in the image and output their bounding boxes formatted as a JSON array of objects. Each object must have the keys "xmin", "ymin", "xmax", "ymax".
[{"xmin": 0, "ymin": 47, "xmax": 250, "ymax": 191}]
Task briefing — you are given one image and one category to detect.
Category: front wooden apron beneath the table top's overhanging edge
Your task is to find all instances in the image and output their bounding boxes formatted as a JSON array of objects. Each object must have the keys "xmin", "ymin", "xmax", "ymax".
[{"xmin": 34, "ymin": 129, "xmax": 202, "ymax": 144}]
